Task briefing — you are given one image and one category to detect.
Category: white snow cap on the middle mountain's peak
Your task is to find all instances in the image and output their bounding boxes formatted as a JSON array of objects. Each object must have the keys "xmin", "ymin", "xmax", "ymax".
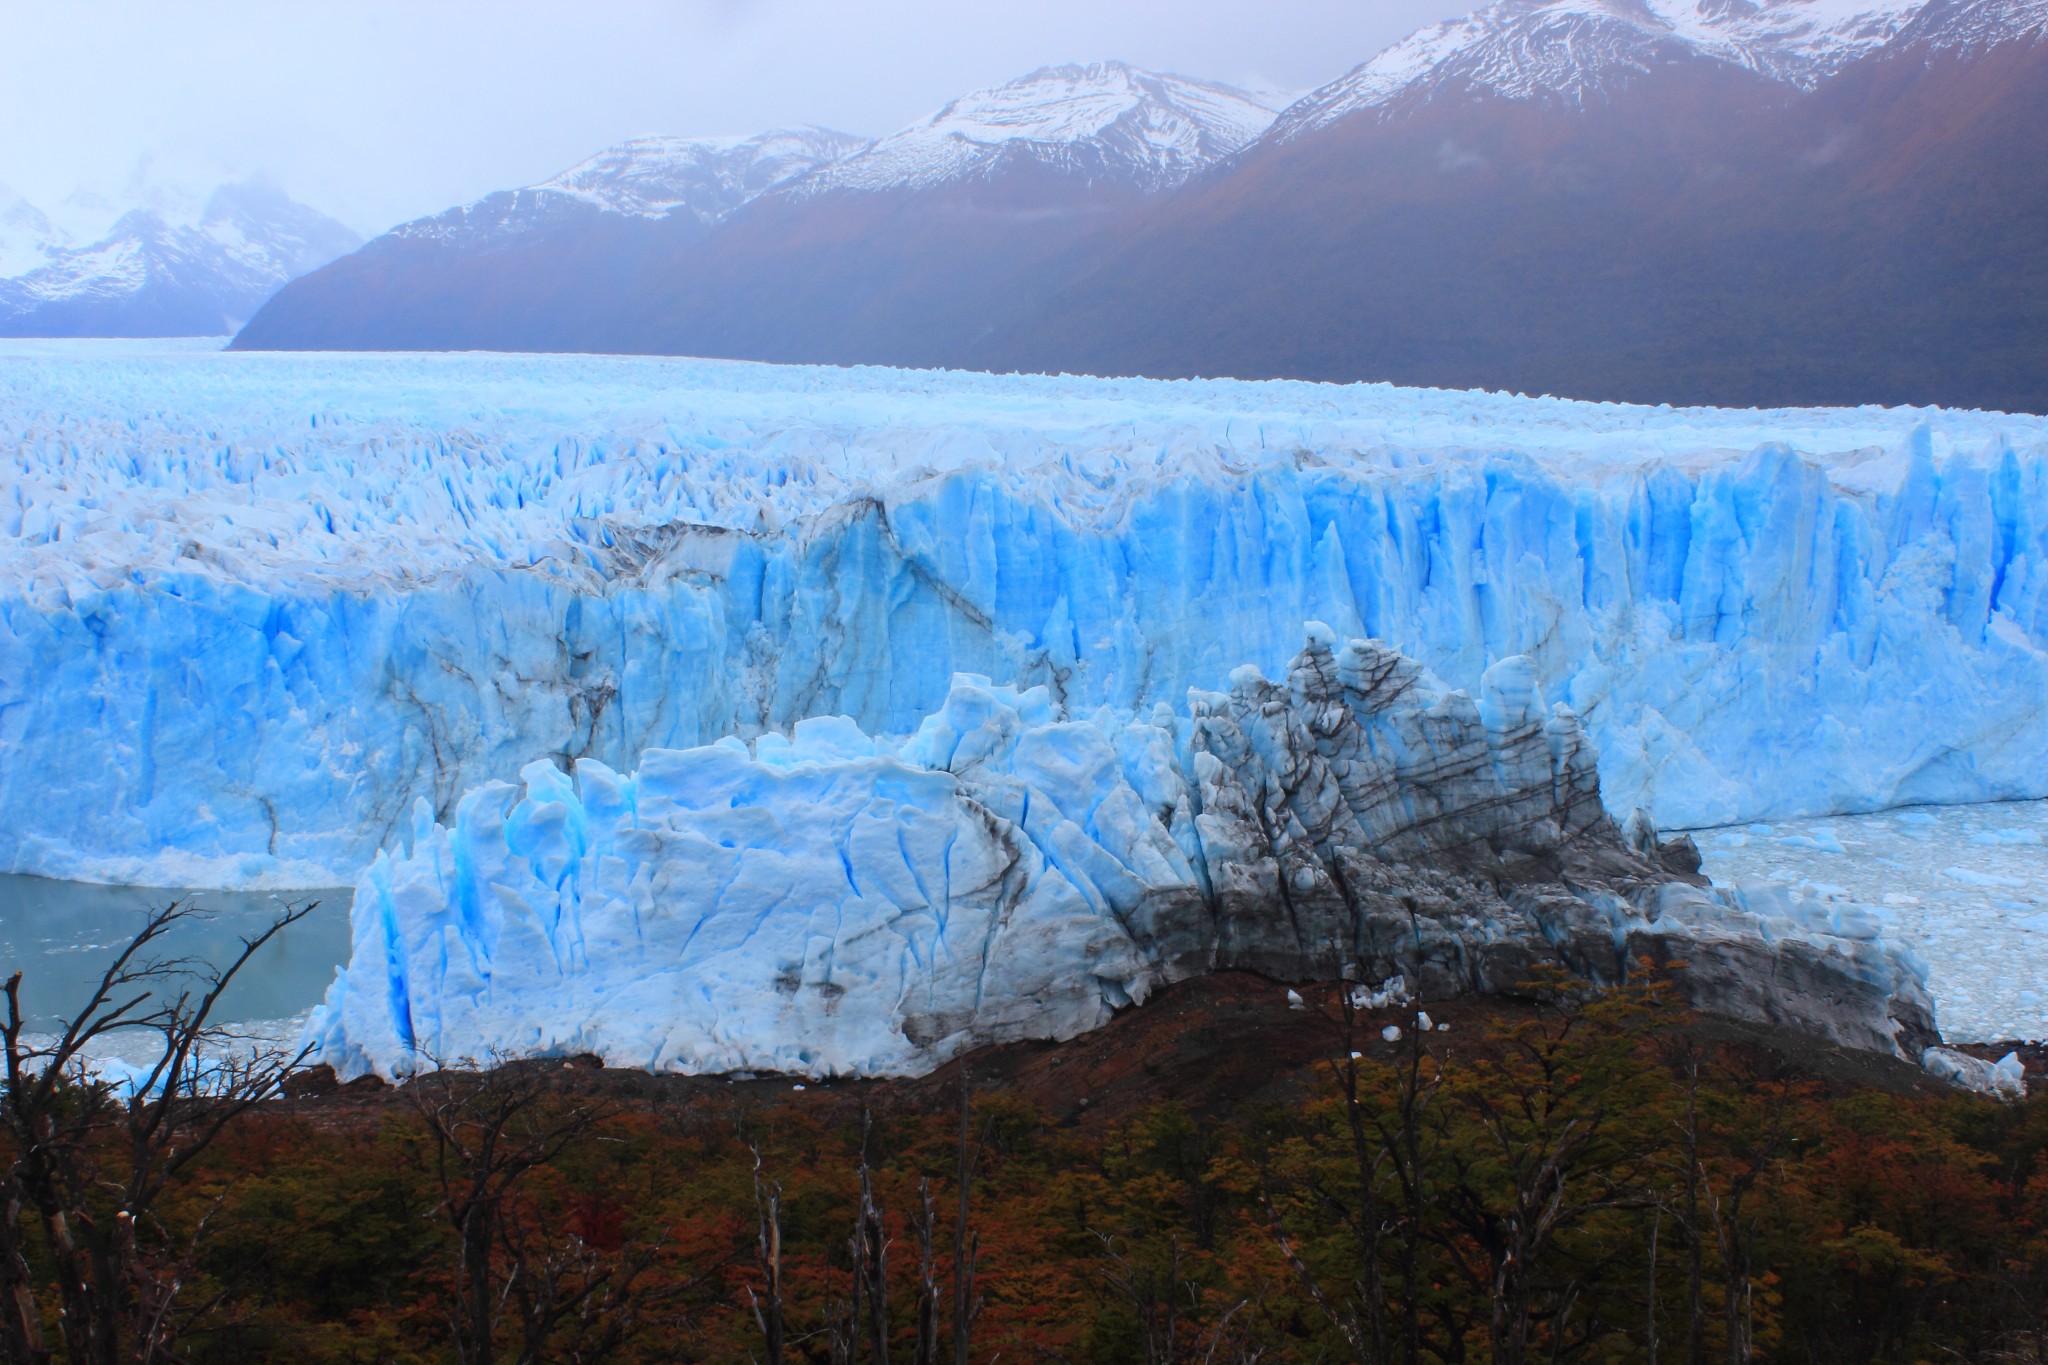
[{"xmin": 797, "ymin": 61, "xmax": 1286, "ymax": 194}]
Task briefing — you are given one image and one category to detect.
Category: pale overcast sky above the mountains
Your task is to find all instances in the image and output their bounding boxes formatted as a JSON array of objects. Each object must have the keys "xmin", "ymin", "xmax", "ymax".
[{"xmin": 0, "ymin": 0, "xmax": 1470, "ymax": 231}]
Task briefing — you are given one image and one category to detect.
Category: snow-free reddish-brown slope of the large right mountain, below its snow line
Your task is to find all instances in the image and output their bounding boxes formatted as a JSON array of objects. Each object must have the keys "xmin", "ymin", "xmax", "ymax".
[{"xmin": 977, "ymin": 17, "xmax": 2048, "ymax": 411}]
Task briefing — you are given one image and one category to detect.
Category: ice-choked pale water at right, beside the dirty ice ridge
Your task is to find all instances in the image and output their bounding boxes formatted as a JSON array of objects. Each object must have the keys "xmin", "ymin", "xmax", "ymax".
[{"xmin": 1694, "ymin": 800, "xmax": 2048, "ymax": 1042}]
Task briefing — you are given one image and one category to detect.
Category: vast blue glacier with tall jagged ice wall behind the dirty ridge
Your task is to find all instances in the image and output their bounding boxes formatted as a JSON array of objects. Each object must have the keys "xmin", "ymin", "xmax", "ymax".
[{"xmin": 0, "ymin": 344, "xmax": 2048, "ymax": 884}]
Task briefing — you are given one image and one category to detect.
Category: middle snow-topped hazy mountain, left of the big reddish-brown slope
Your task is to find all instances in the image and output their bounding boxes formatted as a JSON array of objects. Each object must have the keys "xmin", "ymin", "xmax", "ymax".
[{"xmin": 236, "ymin": 61, "xmax": 1282, "ymax": 351}]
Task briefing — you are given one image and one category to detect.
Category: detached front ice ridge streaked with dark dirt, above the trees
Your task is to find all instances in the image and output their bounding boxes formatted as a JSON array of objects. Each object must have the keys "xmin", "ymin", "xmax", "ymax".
[{"xmin": 309, "ymin": 624, "xmax": 1935, "ymax": 1076}]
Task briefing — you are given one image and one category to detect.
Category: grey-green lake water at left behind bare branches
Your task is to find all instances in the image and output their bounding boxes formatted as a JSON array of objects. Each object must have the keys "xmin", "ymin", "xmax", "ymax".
[{"xmin": 0, "ymin": 876, "xmax": 352, "ymax": 1029}]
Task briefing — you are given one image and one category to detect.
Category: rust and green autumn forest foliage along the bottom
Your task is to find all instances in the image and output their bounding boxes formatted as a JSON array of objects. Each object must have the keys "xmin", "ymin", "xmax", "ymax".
[{"xmin": 12, "ymin": 965, "xmax": 2048, "ymax": 1365}]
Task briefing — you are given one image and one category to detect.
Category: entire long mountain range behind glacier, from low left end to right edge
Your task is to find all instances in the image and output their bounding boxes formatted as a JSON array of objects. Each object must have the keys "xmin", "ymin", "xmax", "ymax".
[{"xmin": 211, "ymin": 0, "xmax": 2048, "ymax": 411}]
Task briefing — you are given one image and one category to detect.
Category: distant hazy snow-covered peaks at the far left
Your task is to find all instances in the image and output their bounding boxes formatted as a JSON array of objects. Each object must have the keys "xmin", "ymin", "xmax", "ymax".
[{"xmin": 0, "ymin": 180, "xmax": 360, "ymax": 336}]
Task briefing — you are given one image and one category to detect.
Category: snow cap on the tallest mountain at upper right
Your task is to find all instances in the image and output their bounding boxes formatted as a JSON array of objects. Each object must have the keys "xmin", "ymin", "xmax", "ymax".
[{"xmin": 1272, "ymin": 0, "xmax": 1925, "ymax": 141}]
